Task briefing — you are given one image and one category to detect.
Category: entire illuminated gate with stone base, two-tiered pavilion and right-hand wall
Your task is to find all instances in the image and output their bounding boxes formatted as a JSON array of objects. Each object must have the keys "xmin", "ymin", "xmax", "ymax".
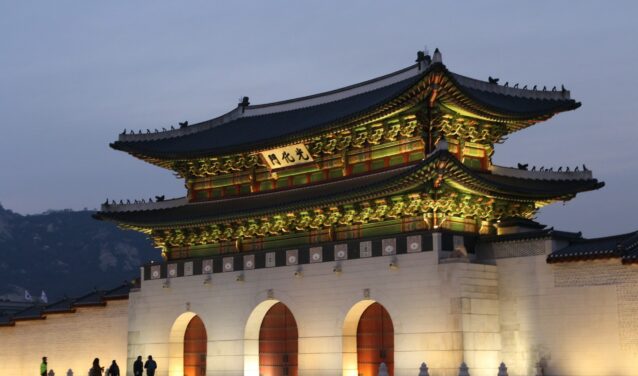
[{"xmin": 0, "ymin": 50, "xmax": 638, "ymax": 376}]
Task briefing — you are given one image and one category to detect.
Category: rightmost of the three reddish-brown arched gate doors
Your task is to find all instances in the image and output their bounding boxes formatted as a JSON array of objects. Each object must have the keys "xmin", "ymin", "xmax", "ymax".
[{"xmin": 357, "ymin": 303, "xmax": 394, "ymax": 376}]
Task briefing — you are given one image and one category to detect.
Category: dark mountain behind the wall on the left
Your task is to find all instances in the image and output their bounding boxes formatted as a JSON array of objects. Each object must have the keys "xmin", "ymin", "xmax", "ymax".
[{"xmin": 0, "ymin": 205, "xmax": 161, "ymax": 302}]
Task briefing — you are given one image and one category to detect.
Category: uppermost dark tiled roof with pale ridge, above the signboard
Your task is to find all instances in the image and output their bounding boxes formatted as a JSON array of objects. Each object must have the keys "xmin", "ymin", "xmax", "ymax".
[{"xmin": 111, "ymin": 55, "xmax": 580, "ymax": 159}]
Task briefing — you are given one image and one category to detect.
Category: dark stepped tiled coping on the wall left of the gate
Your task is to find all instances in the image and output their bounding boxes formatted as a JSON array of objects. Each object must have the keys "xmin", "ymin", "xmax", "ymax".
[{"xmin": 0, "ymin": 282, "xmax": 134, "ymax": 326}]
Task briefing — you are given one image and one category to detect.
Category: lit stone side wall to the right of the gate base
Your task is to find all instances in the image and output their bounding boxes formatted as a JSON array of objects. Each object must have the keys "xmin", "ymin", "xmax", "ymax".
[{"xmin": 487, "ymin": 238, "xmax": 638, "ymax": 376}]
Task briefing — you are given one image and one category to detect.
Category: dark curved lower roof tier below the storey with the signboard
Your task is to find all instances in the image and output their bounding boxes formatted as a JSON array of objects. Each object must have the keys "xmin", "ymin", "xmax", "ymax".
[{"xmin": 95, "ymin": 150, "xmax": 602, "ymax": 228}]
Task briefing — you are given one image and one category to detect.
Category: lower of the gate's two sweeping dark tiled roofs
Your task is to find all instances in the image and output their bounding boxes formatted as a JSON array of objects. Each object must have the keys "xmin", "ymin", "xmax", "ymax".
[{"xmin": 94, "ymin": 150, "xmax": 604, "ymax": 228}]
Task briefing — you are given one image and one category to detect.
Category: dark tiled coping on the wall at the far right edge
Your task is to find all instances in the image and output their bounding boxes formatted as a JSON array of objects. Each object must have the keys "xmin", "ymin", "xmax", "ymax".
[{"xmin": 547, "ymin": 231, "xmax": 638, "ymax": 264}]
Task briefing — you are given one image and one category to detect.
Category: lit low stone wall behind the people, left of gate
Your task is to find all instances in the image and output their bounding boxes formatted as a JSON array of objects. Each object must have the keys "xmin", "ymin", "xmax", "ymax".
[{"xmin": 0, "ymin": 300, "xmax": 128, "ymax": 376}]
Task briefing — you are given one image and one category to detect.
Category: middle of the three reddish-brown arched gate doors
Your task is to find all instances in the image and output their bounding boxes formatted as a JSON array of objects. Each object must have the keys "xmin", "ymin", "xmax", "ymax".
[{"xmin": 259, "ymin": 302, "xmax": 299, "ymax": 376}]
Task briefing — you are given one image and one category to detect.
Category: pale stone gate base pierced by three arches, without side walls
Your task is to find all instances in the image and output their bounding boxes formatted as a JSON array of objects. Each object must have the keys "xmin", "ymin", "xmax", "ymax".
[{"xmin": 129, "ymin": 251, "xmax": 500, "ymax": 376}]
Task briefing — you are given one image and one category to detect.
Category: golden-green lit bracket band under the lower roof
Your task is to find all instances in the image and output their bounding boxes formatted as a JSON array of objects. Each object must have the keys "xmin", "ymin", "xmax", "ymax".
[{"xmin": 123, "ymin": 190, "xmax": 539, "ymax": 247}]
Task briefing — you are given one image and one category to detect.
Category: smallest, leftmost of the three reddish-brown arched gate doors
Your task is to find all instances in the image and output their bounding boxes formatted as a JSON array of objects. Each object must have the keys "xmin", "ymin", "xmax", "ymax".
[{"xmin": 184, "ymin": 316, "xmax": 208, "ymax": 376}]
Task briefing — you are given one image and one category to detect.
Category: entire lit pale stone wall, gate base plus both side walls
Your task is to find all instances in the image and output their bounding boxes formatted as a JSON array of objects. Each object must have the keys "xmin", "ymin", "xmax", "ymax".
[{"xmin": 5, "ymin": 236, "xmax": 638, "ymax": 376}]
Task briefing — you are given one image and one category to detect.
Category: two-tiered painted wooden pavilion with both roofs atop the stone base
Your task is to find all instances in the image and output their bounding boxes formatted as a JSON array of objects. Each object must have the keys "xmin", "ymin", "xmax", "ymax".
[{"xmin": 96, "ymin": 50, "xmax": 603, "ymax": 262}]
